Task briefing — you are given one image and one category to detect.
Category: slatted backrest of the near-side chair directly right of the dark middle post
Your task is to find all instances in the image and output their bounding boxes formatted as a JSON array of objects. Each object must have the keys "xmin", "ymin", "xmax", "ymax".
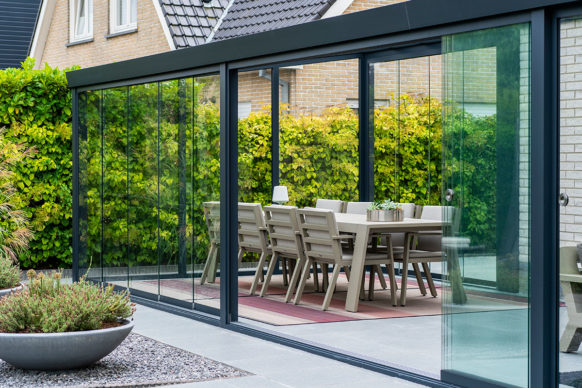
[{"xmin": 238, "ymin": 202, "xmax": 268, "ymax": 252}]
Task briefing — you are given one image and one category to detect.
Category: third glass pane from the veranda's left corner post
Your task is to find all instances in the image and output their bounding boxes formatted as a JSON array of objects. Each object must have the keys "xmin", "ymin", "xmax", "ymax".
[{"xmin": 127, "ymin": 83, "xmax": 158, "ymax": 294}]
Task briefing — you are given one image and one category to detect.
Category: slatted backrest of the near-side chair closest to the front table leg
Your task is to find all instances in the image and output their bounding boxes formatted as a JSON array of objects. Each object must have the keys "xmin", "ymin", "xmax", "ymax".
[{"xmin": 297, "ymin": 209, "xmax": 342, "ymax": 263}]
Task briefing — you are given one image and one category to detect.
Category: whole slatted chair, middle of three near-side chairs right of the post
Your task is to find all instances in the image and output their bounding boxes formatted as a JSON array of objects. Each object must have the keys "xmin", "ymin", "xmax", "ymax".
[{"xmin": 261, "ymin": 205, "xmax": 319, "ymax": 303}]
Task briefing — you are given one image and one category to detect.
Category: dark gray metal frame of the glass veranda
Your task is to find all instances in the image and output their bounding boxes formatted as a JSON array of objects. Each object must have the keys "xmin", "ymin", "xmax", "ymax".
[{"xmin": 67, "ymin": 0, "xmax": 582, "ymax": 388}]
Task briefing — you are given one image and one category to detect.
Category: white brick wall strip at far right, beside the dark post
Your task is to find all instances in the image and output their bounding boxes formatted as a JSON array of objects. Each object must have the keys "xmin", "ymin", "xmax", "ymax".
[{"xmin": 552, "ymin": 19, "xmax": 582, "ymax": 246}]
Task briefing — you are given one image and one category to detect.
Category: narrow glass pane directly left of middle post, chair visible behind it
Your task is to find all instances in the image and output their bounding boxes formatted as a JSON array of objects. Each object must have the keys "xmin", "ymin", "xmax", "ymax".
[{"xmin": 191, "ymin": 75, "xmax": 220, "ymax": 309}]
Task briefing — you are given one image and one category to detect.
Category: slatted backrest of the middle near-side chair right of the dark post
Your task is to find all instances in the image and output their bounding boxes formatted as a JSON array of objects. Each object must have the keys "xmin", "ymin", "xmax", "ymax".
[{"xmin": 265, "ymin": 205, "xmax": 304, "ymax": 258}]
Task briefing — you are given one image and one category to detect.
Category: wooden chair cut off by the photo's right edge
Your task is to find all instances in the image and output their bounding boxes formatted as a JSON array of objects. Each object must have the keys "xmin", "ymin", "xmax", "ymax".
[{"xmin": 560, "ymin": 247, "xmax": 582, "ymax": 353}]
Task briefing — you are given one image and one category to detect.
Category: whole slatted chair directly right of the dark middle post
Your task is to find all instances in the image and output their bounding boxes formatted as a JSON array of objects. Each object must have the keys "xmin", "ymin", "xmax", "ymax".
[{"xmin": 238, "ymin": 202, "xmax": 272, "ymax": 295}]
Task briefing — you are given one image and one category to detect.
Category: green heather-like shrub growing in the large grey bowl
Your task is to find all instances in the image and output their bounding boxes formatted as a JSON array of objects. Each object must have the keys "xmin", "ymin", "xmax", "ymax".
[{"xmin": 0, "ymin": 270, "xmax": 135, "ymax": 333}]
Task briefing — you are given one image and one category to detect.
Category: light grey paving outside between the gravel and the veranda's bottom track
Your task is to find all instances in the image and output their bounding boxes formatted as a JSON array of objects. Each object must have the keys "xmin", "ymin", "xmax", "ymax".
[{"xmin": 134, "ymin": 306, "xmax": 421, "ymax": 388}]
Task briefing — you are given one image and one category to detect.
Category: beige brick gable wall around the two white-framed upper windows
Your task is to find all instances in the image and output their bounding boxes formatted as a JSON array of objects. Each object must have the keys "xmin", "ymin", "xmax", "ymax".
[{"xmin": 37, "ymin": 0, "xmax": 170, "ymax": 68}]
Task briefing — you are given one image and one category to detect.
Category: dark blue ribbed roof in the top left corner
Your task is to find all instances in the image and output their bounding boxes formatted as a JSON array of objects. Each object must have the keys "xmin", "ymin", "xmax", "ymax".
[{"xmin": 0, "ymin": 0, "xmax": 41, "ymax": 69}]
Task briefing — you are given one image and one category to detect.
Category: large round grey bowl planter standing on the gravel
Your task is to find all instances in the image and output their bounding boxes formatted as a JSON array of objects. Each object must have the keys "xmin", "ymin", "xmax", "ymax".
[{"xmin": 0, "ymin": 320, "xmax": 134, "ymax": 370}]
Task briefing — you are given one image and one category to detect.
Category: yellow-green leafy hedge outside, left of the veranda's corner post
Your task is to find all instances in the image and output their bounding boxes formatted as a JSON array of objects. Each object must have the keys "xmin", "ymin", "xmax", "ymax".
[{"xmin": 0, "ymin": 59, "xmax": 72, "ymax": 267}]
